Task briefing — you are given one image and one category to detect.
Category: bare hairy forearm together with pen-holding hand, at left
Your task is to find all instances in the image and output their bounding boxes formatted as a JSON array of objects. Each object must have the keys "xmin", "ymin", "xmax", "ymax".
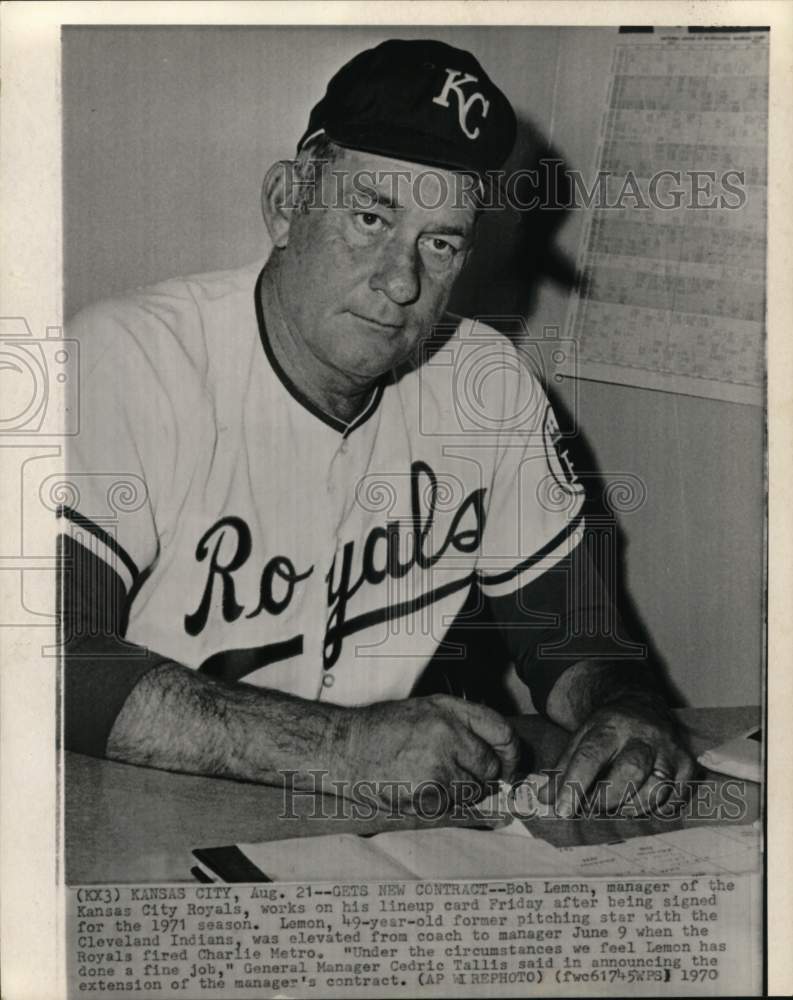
[{"xmin": 107, "ymin": 663, "xmax": 520, "ymax": 809}]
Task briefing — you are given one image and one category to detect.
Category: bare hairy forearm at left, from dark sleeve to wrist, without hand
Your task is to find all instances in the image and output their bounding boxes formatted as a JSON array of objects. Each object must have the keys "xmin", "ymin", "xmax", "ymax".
[{"xmin": 107, "ymin": 663, "xmax": 349, "ymax": 787}]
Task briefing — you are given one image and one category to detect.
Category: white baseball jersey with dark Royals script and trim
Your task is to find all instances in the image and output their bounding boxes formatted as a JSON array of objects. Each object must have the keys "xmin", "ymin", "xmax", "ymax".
[{"xmin": 63, "ymin": 262, "xmax": 584, "ymax": 705}]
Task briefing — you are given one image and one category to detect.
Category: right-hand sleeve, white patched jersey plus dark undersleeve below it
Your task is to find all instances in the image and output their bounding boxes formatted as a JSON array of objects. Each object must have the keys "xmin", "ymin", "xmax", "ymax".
[{"xmin": 477, "ymin": 348, "xmax": 663, "ymax": 713}]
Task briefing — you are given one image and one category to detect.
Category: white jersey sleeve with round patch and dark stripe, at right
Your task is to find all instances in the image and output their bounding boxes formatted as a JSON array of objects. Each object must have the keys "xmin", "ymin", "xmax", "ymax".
[{"xmin": 477, "ymin": 344, "xmax": 584, "ymax": 597}]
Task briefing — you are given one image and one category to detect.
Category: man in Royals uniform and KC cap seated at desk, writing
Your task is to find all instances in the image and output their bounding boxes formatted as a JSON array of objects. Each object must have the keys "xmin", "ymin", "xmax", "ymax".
[{"xmin": 60, "ymin": 41, "xmax": 691, "ymax": 814}]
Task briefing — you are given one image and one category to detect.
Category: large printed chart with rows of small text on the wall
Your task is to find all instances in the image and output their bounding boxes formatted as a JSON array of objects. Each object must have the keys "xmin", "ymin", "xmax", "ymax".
[{"xmin": 568, "ymin": 29, "xmax": 768, "ymax": 405}]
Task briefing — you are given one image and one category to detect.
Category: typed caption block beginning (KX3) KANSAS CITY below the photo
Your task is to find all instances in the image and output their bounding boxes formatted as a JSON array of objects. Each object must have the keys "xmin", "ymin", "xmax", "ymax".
[{"xmin": 67, "ymin": 874, "xmax": 762, "ymax": 998}]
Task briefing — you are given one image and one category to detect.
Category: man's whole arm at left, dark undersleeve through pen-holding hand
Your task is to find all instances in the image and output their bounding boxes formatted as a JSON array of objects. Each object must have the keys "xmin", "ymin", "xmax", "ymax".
[{"xmin": 59, "ymin": 535, "xmax": 518, "ymax": 798}]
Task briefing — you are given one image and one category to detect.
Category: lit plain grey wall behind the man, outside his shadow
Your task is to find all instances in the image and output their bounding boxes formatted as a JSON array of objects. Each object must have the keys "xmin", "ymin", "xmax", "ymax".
[{"xmin": 63, "ymin": 27, "xmax": 763, "ymax": 705}]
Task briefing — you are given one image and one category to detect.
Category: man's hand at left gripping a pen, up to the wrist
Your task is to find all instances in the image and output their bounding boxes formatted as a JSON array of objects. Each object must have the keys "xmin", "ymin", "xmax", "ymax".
[{"xmin": 339, "ymin": 695, "xmax": 520, "ymax": 806}]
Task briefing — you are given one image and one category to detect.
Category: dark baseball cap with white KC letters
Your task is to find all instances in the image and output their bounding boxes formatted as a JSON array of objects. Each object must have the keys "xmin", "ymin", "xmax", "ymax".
[{"xmin": 297, "ymin": 39, "xmax": 516, "ymax": 177}]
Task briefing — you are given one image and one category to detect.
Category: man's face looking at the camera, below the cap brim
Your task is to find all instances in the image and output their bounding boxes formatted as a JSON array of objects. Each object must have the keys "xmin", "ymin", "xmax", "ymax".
[{"xmin": 280, "ymin": 150, "xmax": 475, "ymax": 385}]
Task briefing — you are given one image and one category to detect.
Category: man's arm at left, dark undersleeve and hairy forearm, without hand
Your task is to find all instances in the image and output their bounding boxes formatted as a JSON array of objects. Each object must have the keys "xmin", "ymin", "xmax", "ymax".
[{"xmin": 58, "ymin": 533, "xmax": 348, "ymax": 787}]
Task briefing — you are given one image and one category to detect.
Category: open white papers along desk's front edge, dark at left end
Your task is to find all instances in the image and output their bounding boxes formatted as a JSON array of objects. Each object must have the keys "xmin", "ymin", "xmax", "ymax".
[{"xmin": 192, "ymin": 823, "xmax": 760, "ymax": 882}]
